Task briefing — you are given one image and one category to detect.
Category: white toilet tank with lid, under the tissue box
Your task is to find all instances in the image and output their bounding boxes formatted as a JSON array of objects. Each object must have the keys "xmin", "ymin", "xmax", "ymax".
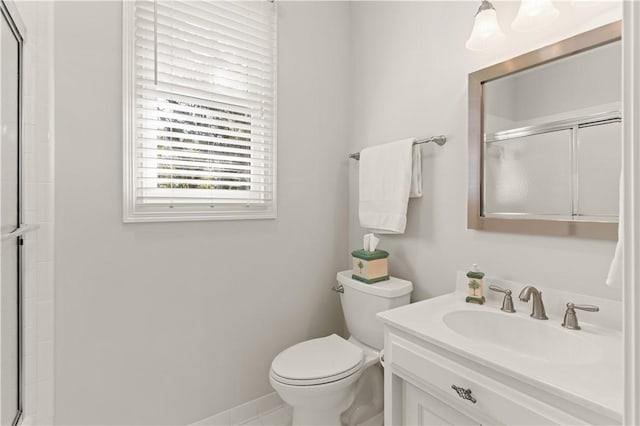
[{"xmin": 337, "ymin": 270, "xmax": 413, "ymax": 350}]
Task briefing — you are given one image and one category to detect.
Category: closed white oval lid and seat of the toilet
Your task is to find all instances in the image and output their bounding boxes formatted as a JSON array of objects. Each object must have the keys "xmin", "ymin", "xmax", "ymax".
[{"xmin": 271, "ymin": 334, "xmax": 364, "ymax": 385}]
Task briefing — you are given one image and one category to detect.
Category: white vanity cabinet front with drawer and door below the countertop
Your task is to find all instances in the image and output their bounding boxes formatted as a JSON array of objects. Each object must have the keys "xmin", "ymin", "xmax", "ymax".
[{"xmin": 385, "ymin": 325, "xmax": 617, "ymax": 425}]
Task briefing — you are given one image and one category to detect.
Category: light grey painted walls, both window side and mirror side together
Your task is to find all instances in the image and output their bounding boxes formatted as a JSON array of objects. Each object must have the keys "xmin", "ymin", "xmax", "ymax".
[{"xmin": 54, "ymin": 2, "xmax": 620, "ymax": 424}]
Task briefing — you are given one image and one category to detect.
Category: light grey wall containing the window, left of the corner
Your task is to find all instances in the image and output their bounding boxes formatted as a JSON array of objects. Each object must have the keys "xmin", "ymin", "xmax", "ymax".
[{"xmin": 55, "ymin": 2, "xmax": 349, "ymax": 425}]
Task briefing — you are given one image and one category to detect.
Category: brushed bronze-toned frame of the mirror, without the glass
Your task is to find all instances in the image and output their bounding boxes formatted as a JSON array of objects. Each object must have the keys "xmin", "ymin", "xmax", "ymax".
[{"xmin": 467, "ymin": 21, "xmax": 622, "ymax": 240}]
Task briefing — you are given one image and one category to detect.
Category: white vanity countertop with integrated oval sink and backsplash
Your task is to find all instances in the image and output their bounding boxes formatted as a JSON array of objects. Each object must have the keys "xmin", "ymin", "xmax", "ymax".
[{"xmin": 378, "ymin": 290, "xmax": 624, "ymax": 424}]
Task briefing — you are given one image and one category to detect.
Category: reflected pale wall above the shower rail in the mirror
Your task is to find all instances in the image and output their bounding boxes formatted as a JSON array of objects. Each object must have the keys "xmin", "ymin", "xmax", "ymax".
[{"xmin": 482, "ymin": 40, "xmax": 622, "ymax": 135}]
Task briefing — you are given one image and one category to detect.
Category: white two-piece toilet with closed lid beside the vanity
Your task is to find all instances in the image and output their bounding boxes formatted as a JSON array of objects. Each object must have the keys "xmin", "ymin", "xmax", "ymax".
[{"xmin": 269, "ymin": 270, "xmax": 413, "ymax": 426}]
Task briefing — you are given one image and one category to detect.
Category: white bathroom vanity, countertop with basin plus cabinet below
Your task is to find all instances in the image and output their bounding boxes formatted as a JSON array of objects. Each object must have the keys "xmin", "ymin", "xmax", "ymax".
[{"xmin": 378, "ymin": 274, "xmax": 623, "ymax": 425}]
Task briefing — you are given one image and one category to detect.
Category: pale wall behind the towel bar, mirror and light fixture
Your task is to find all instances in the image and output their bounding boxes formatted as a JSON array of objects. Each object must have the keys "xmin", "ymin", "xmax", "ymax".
[{"xmin": 349, "ymin": 1, "xmax": 620, "ymax": 300}]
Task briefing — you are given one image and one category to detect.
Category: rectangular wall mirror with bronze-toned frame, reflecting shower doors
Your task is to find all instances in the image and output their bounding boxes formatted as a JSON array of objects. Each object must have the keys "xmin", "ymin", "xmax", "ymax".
[{"xmin": 468, "ymin": 22, "xmax": 622, "ymax": 239}]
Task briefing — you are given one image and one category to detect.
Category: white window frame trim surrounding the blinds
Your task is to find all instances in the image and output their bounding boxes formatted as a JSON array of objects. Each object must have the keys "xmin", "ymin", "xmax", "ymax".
[{"xmin": 122, "ymin": 0, "xmax": 278, "ymax": 223}]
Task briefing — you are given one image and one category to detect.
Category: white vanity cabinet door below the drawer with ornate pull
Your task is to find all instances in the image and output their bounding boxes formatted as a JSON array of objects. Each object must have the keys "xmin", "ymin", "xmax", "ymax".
[{"xmin": 402, "ymin": 381, "xmax": 480, "ymax": 426}]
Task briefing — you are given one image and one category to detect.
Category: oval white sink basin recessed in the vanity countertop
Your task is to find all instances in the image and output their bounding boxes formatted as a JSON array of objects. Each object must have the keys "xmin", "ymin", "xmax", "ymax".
[{"xmin": 442, "ymin": 310, "xmax": 602, "ymax": 364}]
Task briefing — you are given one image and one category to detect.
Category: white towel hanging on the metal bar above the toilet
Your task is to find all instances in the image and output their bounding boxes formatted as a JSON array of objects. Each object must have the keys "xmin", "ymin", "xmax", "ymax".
[{"xmin": 359, "ymin": 138, "xmax": 422, "ymax": 234}]
